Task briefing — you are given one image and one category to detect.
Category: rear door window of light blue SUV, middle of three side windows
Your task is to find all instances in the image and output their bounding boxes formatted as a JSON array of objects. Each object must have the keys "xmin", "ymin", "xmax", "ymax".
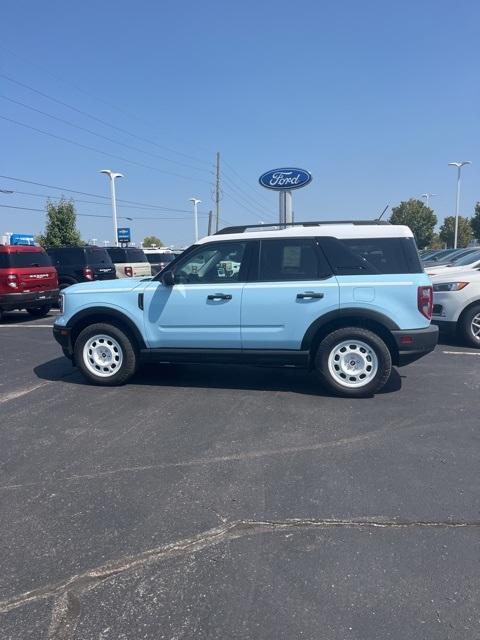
[{"xmin": 259, "ymin": 238, "xmax": 331, "ymax": 282}]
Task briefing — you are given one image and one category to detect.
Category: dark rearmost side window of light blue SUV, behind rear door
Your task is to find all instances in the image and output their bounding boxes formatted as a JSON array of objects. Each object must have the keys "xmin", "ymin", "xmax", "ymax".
[{"xmin": 320, "ymin": 238, "xmax": 423, "ymax": 276}]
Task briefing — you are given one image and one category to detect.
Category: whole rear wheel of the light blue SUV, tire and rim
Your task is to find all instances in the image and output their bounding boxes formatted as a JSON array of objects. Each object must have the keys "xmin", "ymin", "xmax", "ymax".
[{"xmin": 315, "ymin": 327, "xmax": 392, "ymax": 398}]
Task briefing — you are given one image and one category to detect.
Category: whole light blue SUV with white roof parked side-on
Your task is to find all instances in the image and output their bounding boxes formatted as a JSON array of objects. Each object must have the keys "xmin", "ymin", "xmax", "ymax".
[{"xmin": 53, "ymin": 222, "xmax": 438, "ymax": 397}]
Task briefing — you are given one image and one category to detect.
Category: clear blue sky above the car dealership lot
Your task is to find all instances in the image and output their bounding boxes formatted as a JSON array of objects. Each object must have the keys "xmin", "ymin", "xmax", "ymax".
[{"xmin": 0, "ymin": 0, "xmax": 480, "ymax": 246}]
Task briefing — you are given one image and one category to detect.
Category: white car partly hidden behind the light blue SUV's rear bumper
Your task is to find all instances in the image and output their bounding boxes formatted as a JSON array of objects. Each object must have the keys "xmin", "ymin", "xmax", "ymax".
[{"xmin": 432, "ymin": 270, "xmax": 480, "ymax": 349}]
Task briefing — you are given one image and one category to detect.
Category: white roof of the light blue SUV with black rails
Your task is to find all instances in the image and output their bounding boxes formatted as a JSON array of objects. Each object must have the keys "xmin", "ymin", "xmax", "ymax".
[{"xmin": 197, "ymin": 221, "xmax": 413, "ymax": 244}]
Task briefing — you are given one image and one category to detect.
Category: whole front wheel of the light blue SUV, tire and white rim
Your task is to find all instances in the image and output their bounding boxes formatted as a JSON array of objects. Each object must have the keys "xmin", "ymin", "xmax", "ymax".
[{"xmin": 74, "ymin": 323, "xmax": 138, "ymax": 386}]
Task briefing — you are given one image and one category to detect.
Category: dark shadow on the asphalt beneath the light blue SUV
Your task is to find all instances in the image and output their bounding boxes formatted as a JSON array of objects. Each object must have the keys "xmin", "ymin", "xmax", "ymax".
[{"xmin": 33, "ymin": 358, "xmax": 402, "ymax": 396}]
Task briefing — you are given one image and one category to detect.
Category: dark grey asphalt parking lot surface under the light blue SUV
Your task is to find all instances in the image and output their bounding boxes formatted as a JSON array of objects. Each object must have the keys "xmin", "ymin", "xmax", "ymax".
[{"xmin": 0, "ymin": 313, "xmax": 480, "ymax": 640}]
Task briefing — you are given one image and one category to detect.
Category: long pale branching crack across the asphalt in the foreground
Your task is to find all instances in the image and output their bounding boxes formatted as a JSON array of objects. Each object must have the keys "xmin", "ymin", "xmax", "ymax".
[{"xmin": 0, "ymin": 516, "xmax": 480, "ymax": 620}]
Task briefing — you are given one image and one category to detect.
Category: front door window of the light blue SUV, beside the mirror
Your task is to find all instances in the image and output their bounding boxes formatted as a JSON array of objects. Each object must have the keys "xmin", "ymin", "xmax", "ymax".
[{"xmin": 174, "ymin": 242, "xmax": 246, "ymax": 284}]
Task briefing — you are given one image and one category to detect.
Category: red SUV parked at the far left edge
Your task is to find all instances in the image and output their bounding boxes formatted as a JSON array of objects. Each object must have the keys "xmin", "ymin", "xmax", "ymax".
[{"xmin": 0, "ymin": 245, "xmax": 58, "ymax": 320}]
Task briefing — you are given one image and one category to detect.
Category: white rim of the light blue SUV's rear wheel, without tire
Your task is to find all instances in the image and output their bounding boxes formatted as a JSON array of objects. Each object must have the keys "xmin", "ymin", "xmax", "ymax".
[{"xmin": 328, "ymin": 339, "xmax": 378, "ymax": 389}]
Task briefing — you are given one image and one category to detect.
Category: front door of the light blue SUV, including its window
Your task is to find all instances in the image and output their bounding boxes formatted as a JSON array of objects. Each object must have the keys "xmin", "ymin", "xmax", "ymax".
[{"xmin": 144, "ymin": 241, "xmax": 251, "ymax": 349}]
